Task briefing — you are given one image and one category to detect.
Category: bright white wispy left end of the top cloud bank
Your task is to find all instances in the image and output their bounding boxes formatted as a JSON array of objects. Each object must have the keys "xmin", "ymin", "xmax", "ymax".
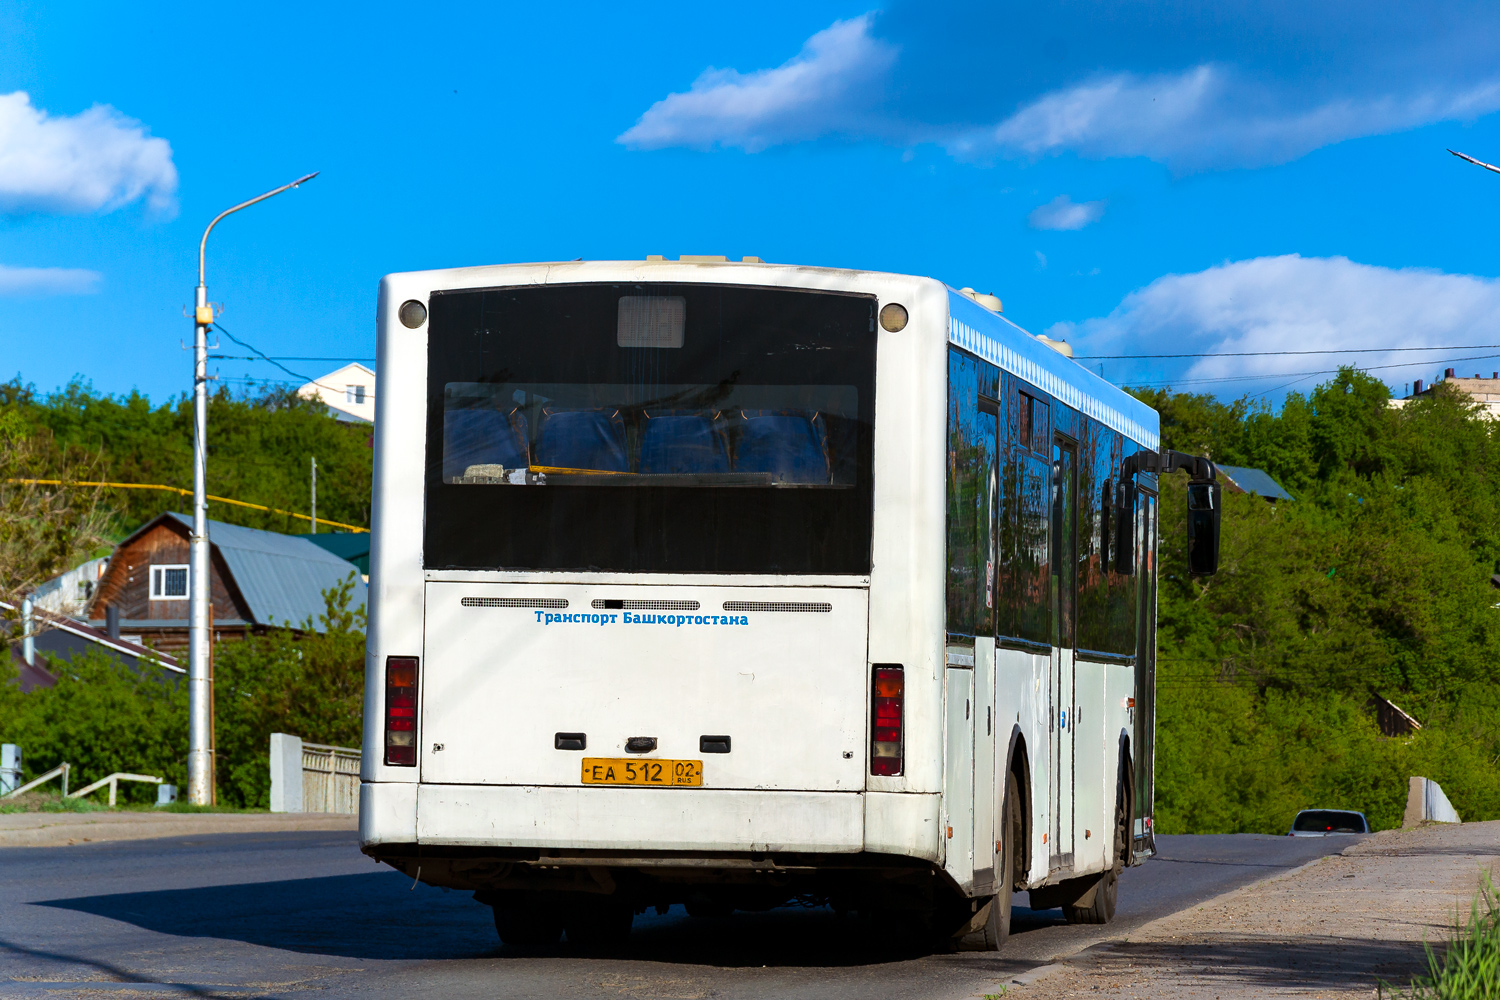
[{"xmin": 617, "ymin": 13, "xmax": 896, "ymax": 153}]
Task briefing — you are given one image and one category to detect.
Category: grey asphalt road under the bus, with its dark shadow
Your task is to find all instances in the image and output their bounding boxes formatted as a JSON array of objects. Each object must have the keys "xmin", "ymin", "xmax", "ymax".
[{"xmin": 0, "ymin": 832, "xmax": 1349, "ymax": 1000}]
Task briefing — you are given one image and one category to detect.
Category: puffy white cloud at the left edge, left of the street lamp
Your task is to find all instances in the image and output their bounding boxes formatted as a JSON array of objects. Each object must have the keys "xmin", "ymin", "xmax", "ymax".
[{"xmin": 0, "ymin": 90, "xmax": 177, "ymax": 213}]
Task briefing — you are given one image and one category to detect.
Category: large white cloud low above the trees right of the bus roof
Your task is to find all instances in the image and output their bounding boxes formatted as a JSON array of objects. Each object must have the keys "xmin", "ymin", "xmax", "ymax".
[{"xmin": 1047, "ymin": 253, "xmax": 1500, "ymax": 391}]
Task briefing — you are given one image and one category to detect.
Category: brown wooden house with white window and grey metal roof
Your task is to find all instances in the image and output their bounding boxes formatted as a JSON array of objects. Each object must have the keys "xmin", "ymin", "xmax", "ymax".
[{"xmin": 89, "ymin": 513, "xmax": 366, "ymax": 652}]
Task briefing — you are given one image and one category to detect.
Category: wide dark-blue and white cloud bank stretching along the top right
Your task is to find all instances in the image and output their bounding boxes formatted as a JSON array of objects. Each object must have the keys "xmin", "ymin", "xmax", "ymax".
[{"xmin": 618, "ymin": 10, "xmax": 1500, "ymax": 171}]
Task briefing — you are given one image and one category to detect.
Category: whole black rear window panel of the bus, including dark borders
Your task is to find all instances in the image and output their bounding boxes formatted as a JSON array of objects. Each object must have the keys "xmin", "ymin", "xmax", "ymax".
[{"xmin": 425, "ymin": 283, "xmax": 876, "ymax": 574}]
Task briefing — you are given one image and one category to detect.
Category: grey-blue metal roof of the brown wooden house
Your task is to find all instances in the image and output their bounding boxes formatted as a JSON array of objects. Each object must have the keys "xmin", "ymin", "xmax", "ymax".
[{"xmin": 170, "ymin": 513, "xmax": 366, "ymax": 631}]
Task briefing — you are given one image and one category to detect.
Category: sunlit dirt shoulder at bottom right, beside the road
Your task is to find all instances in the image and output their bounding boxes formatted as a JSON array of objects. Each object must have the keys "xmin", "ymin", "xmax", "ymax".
[{"xmin": 1005, "ymin": 822, "xmax": 1500, "ymax": 1000}]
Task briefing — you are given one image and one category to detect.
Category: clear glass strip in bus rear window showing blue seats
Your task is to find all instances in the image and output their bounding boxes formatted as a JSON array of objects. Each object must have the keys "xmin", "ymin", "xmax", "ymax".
[{"xmin": 443, "ymin": 382, "xmax": 860, "ymax": 489}]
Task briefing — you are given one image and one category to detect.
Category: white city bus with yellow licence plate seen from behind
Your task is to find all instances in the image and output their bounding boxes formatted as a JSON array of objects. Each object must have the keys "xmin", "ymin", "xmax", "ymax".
[{"xmin": 360, "ymin": 258, "xmax": 1218, "ymax": 949}]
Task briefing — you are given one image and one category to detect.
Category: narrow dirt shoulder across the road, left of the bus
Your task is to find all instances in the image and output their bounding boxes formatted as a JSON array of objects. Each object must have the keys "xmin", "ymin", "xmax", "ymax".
[{"xmin": 0, "ymin": 813, "xmax": 359, "ymax": 847}]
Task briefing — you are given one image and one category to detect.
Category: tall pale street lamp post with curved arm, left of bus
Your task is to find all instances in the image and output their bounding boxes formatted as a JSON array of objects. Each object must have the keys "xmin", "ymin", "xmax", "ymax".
[{"xmin": 188, "ymin": 172, "xmax": 318, "ymax": 805}]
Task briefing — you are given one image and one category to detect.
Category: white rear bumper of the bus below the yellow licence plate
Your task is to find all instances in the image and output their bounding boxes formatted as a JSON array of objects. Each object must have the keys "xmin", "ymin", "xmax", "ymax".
[{"xmin": 360, "ymin": 783, "xmax": 866, "ymax": 853}]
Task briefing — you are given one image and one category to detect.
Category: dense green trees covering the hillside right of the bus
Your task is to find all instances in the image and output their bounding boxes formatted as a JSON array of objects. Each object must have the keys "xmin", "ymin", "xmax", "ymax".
[{"xmin": 1143, "ymin": 370, "xmax": 1500, "ymax": 832}]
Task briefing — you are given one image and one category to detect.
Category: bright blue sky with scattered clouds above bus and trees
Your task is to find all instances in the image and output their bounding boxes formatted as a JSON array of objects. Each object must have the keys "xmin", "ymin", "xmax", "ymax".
[{"xmin": 0, "ymin": 0, "xmax": 1500, "ymax": 400}]
